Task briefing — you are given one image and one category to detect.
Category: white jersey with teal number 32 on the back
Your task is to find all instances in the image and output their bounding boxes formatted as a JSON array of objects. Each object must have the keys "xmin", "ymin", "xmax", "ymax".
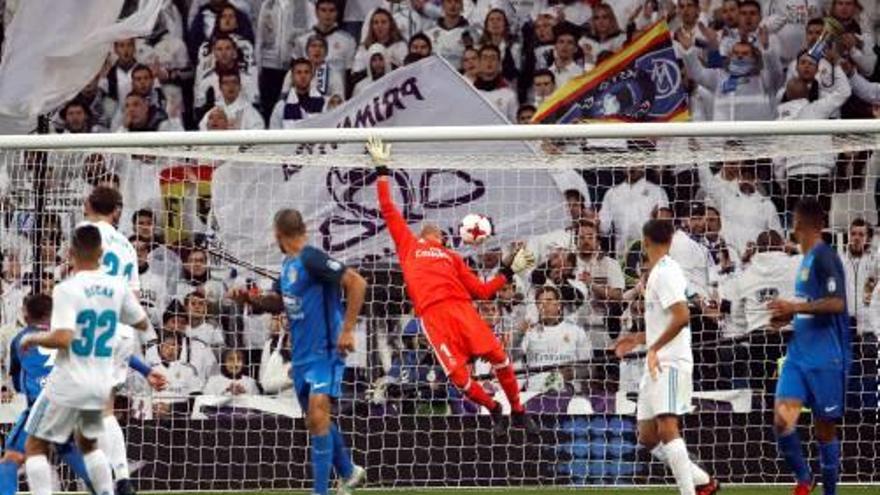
[{"xmin": 45, "ymin": 271, "xmax": 146, "ymax": 410}]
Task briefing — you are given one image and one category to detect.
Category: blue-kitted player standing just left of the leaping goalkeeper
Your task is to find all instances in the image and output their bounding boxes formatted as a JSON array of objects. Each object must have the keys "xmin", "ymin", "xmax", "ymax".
[{"xmin": 235, "ymin": 209, "xmax": 367, "ymax": 495}]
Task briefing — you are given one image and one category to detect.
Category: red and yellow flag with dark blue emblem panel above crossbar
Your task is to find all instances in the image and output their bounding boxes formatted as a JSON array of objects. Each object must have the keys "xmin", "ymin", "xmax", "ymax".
[{"xmin": 532, "ymin": 21, "xmax": 690, "ymax": 124}]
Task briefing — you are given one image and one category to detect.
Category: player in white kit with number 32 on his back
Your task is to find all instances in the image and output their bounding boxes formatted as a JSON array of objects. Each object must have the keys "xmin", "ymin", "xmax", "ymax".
[{"xmin": 21, "ymin": 225, "xmax": 149, "ymax": 495}]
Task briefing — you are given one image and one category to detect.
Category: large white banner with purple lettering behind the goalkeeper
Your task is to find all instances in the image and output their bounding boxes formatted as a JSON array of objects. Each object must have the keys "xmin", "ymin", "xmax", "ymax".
[{"xmin": 211, "ymin": 57, "xmax": 580, "ymax": 268}]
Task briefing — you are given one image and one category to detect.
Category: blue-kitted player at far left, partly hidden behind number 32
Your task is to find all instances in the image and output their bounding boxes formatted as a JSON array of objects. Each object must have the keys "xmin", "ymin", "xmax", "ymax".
[{"xmin": 0, "ymin": 295, "xmax": 92, "ymax": 495}]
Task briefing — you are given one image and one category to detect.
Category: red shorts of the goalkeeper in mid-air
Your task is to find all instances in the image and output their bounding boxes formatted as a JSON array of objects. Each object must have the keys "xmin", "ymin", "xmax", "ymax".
[{"xmin": 421, "ymin": 301, "xmax": 503, "ymax": 375}]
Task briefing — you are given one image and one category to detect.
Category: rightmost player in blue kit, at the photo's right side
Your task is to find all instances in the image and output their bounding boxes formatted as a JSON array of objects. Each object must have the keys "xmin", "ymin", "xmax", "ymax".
[{"xmin": 768, "ymin": 198, "xmax": 852, "ymax": 495}]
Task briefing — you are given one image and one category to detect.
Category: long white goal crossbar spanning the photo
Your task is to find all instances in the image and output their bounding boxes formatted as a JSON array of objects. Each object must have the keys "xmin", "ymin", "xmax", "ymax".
[{"xmin": 0, "ymin": 120, "xmax": 880, "ymax": 150}]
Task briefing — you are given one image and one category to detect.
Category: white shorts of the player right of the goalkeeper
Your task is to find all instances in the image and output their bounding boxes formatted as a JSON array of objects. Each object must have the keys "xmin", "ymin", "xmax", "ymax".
[{"xmin": 636, "ymin": 366, "xmax": 694, "ymax": 421}]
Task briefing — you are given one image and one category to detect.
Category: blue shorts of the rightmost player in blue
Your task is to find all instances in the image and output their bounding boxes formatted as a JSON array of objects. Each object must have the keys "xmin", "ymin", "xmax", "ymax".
[{"xmin": 776, "ymin": 360, "xmax": 846, "ymax": 420}]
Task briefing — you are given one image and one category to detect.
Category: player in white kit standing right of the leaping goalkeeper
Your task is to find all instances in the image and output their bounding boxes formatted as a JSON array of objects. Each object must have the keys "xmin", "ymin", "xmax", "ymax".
[{"xmin": 615, "ymin": 219, "xmax": 719, "ymax": 495}]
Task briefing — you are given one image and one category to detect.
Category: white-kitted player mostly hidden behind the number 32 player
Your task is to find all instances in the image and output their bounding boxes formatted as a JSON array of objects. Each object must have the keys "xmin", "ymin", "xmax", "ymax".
[{"xmin": 81, "ymin": 186, "xmax": 156, "ymax": 495}]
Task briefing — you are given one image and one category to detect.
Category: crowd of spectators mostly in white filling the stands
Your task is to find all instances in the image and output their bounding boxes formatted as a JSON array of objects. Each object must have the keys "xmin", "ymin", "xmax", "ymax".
[{"xmin": 0, "ymin": 0, "xmax": 880, "ymax": 416}]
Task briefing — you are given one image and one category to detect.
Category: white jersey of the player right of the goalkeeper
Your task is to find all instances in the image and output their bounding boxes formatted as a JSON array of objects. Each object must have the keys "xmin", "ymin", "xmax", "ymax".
[{"xmin": 645, "ymin": 256, "xmax": 694, "ymax": 373}]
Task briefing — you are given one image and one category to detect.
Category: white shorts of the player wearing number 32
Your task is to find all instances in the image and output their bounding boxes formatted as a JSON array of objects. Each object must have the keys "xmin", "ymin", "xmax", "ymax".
[{"xmin": 24, "ymin": 394, "xmax": 104, "ymax": 443}]
